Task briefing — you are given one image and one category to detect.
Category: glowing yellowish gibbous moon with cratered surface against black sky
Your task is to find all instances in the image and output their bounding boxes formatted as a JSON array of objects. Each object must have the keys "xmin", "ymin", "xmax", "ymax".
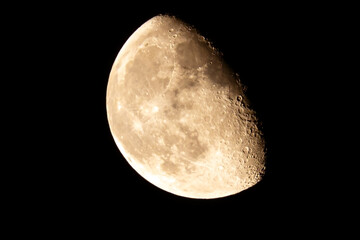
[{"xmin": 106, "ymin": 15, "xmax": 266, "ymax": 199}]
